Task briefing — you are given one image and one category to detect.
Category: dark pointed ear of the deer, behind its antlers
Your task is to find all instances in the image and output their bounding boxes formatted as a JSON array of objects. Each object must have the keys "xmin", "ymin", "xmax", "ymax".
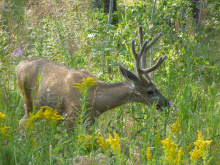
[{"xmin": 118, "ymin": 64, "xmax": 141, "ymax": 84}]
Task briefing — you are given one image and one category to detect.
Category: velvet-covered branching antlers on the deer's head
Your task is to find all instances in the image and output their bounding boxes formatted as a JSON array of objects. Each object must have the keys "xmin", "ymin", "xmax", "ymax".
[{"xmin": 131, "ymin": 26, "xmax": 167, "ymax": 80}]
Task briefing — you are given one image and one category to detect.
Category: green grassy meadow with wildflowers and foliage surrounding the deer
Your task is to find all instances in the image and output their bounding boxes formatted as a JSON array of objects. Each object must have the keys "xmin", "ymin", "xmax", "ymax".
[{"xmin": 0, "ymin": 0, "xmax": 220, "ymax": 165}]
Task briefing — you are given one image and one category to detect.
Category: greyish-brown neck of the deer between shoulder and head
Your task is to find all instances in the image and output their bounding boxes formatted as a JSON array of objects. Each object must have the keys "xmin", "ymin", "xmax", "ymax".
[{"xmin": 91, "ymin": 81, "xmax": 134, "ymax": 114}]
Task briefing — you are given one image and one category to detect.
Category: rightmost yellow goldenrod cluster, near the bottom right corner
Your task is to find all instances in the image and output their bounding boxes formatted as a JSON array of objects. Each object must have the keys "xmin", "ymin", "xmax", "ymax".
[{"xmin": 189, "ymin": 130, "xmax": 212, "ymax": 161}]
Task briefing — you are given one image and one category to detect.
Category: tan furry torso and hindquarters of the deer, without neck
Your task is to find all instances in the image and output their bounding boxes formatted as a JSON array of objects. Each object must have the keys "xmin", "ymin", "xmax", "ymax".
[{"xmin": 17, "ymin": 57, "xmax": 94, "ymax": 126}]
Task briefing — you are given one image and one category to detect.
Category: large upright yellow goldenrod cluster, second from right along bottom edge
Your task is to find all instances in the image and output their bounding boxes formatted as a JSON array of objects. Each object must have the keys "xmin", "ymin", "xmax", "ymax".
[{"xmin": 161, "ymin": 133, "xmax": 177, "ymax": 162}]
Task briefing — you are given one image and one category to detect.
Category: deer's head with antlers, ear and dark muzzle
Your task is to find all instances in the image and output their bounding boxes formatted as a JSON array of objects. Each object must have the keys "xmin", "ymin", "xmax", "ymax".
[{"xmin": 119, "ymin": 26, "xmax": 168, "ymax": 111}]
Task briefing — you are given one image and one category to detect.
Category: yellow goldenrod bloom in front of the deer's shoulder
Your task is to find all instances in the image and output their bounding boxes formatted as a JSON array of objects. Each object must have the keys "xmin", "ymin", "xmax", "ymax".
[{"xmin": 73, "ymin": 77, "xmax": 98, "ymax": 91}]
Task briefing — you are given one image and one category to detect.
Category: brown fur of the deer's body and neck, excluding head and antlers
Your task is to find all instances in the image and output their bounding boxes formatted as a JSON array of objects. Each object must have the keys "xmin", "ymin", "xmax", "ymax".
[{"xmin": 17, "ymin": 57, "xmax": 168, "ymax": 128}]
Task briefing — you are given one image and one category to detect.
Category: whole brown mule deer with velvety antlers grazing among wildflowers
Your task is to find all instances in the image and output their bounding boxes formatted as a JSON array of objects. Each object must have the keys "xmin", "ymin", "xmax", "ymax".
[{"xmin": 17, "ymin": 26, "xmax": 168, "ymax": 127}]
